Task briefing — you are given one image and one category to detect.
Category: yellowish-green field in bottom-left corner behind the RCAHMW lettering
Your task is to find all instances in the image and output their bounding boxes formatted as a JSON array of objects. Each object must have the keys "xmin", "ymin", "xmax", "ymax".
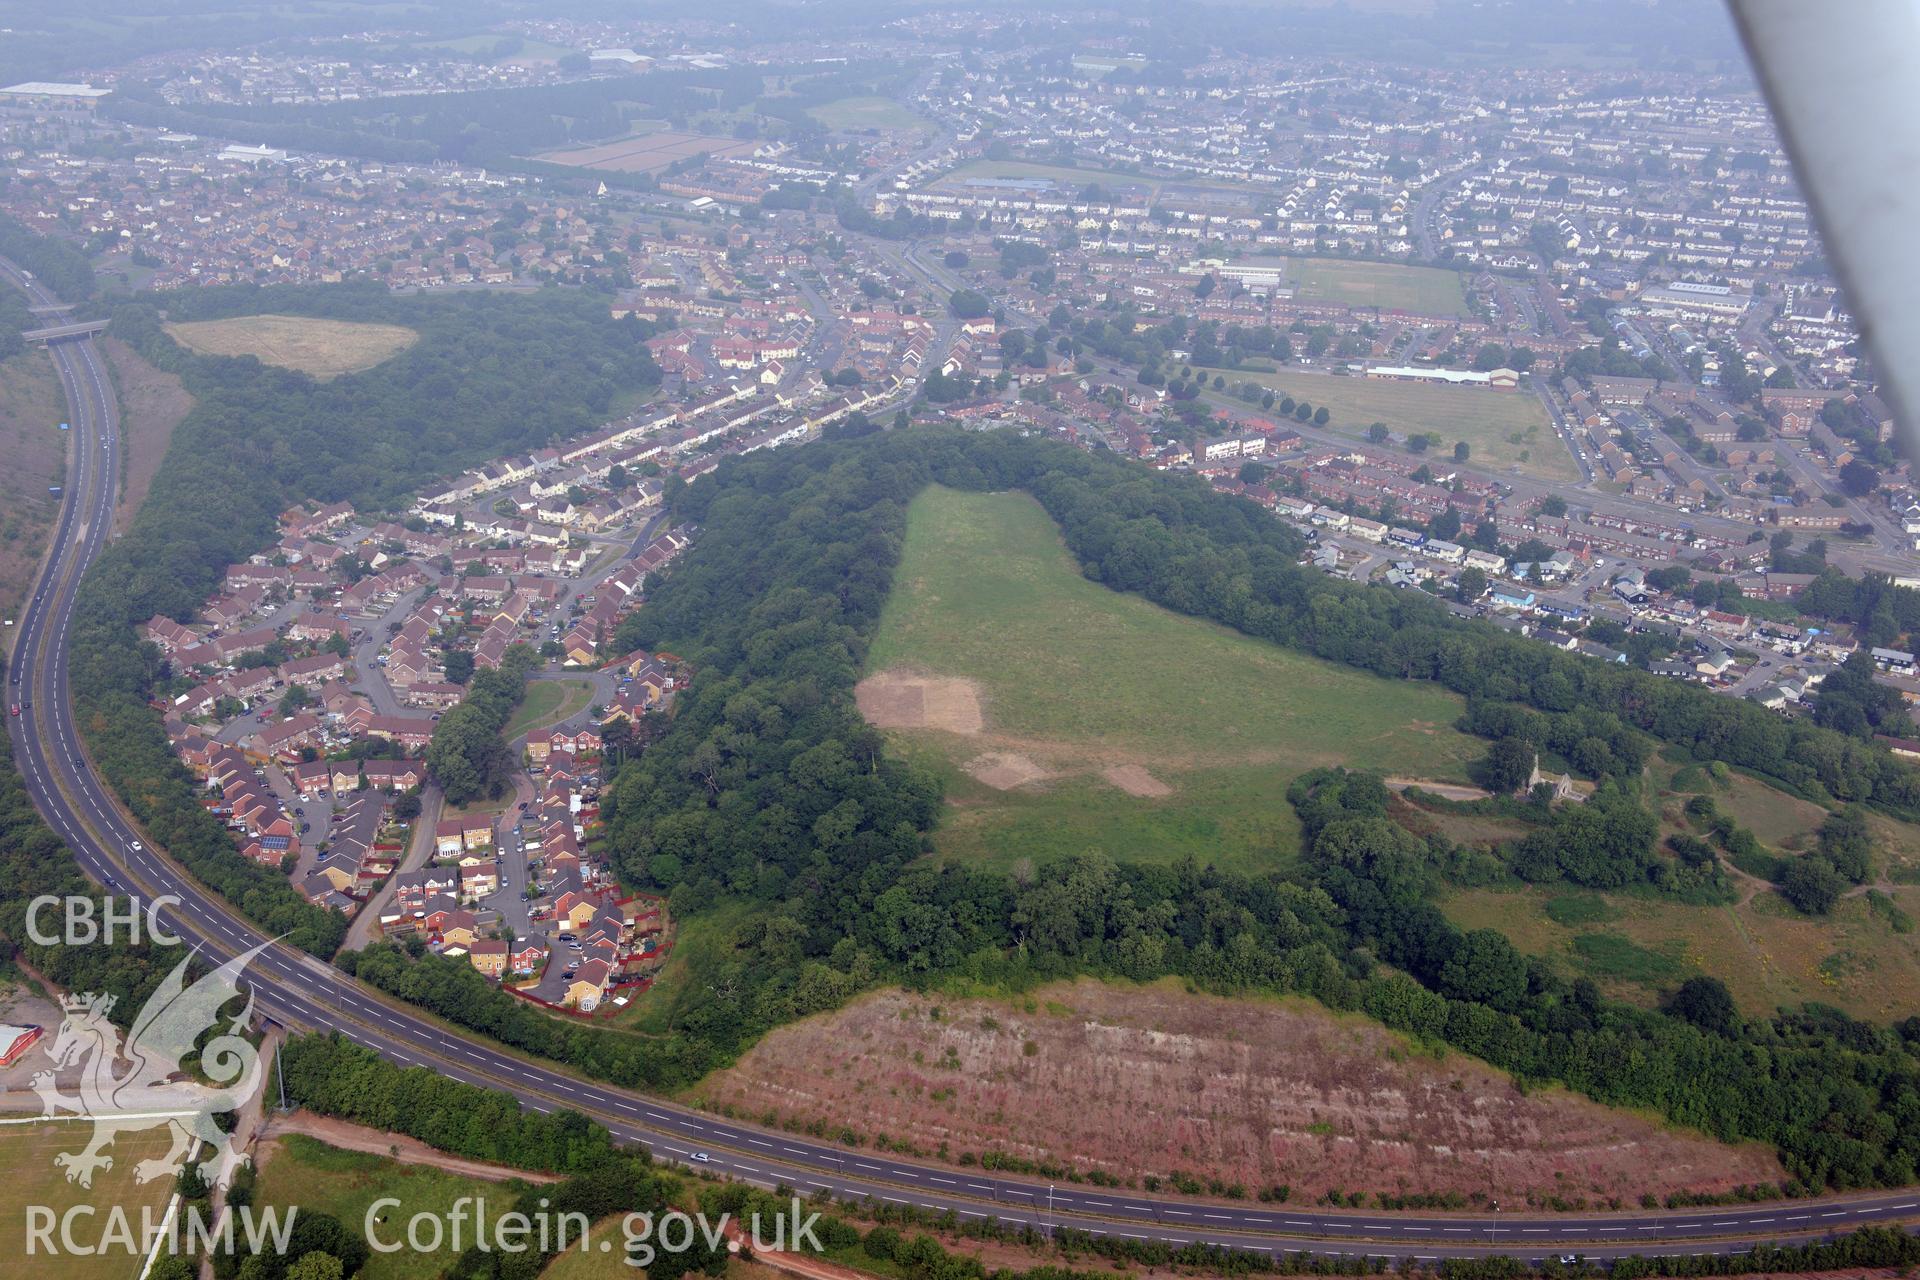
[{"xmin": 0, "ymin": 1120, "xmax": 173, "ymax": 1280}]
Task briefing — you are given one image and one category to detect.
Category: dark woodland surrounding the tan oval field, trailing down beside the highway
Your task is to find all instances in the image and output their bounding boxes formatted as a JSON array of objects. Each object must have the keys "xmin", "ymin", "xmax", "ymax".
[{"xmin": 73, "ymin": 286, "xmax": 659, "ymax": 956}]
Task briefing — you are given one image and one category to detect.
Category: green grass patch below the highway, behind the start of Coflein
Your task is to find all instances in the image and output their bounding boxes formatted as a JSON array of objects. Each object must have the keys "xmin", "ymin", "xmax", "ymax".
[{"xmin": 253, "ymin": 1134, "xmax": 524, "ymax": 1280}]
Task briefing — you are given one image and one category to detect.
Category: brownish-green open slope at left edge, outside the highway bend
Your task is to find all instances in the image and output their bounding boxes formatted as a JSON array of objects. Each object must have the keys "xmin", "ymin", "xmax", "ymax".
[{"xmin": 0, "ymin": 349, "xmax": 67, "ymax": 645}]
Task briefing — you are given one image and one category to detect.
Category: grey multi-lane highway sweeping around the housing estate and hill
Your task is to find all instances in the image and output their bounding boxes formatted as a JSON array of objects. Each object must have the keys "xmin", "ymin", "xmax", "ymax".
[{"xmin": 0, "ymin": 263, "xmax": 1920, "ymax": 1259}]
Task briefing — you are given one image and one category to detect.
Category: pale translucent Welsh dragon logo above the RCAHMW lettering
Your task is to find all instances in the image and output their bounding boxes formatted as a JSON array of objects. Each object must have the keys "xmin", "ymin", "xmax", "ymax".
[{"xmin": 33, "ymin": 942, "xmax": 269, "ymax": 1188}]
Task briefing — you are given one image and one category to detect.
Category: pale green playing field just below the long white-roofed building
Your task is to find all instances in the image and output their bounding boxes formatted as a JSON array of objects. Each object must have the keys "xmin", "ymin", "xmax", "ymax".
[{"xmin": 1196, "ymin": 368, "xmax": 1580, "ymax": 482}]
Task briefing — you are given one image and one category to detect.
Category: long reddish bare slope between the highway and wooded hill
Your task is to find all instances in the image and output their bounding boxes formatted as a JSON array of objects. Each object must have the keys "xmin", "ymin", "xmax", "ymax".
[{"xmin": 695, "ymin": 979, "xmax": 1780, "ymax": 1203}]
